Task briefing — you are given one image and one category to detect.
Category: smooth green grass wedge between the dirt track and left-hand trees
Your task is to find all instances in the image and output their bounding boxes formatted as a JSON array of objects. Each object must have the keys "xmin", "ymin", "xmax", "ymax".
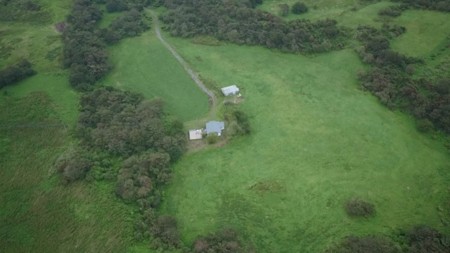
[{"xmin": 103, "ymin": 30, "xmax": 209, "ymax": 121}]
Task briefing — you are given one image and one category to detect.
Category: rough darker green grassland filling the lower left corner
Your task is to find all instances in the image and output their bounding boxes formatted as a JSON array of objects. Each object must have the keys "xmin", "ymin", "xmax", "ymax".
[{"xmin": 0, "ymin": 92, "xmax": 133, "ymax": 253}]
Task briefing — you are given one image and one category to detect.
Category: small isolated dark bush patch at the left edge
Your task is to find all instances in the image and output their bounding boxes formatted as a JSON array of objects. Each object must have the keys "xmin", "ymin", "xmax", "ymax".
[{"xmin": 0, "ymin": 60, "xmax": 36, "ymax": 89}]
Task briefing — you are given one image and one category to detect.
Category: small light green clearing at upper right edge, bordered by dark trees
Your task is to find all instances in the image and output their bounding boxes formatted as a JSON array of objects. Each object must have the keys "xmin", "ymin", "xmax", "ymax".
[{"xmin": 392, "ymin": 10, "xmax": 450, "ymax": 57}]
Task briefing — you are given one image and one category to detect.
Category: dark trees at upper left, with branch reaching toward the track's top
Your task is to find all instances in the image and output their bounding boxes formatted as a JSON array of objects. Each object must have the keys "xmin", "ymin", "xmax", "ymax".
[{"xmin": 63, "ymin": 0, "xmax": 148, "ymax": 90}]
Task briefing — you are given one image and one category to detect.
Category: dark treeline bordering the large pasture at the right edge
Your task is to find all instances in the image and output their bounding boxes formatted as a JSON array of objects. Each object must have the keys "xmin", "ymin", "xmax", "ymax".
[{"xmin": 357, "ymin": 25, "xmax": 450, "ymax": 133}]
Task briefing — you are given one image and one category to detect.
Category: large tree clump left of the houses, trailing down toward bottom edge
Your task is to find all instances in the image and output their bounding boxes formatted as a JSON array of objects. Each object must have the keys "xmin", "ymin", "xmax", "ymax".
[{"xmin": 75, "ymin": 87, "xmax": 186, "ymax": 247}]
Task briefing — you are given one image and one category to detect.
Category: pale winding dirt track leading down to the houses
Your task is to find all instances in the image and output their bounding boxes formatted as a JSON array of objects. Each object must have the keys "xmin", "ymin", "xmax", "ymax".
[{"xmin": 150, "ymin": 10, "xmax": 217, "ymax": 109}]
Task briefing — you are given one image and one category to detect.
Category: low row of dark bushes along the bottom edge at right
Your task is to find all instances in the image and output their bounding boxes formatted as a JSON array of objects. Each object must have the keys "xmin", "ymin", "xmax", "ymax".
[{"xmin": 326, "ymin": 225, "xmax": 450, "ymax": 253}]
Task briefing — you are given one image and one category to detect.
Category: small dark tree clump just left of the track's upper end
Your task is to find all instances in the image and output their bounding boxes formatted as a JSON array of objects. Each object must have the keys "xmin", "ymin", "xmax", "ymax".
[{"xmin": 103, "ymin": 9, "xmax": 149, "ymax": 44}]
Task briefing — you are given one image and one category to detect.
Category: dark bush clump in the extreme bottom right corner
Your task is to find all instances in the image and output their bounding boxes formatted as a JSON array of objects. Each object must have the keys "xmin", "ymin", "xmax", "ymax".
[{"xmin": 407, "ymin": 226, "xmax": 450, "ymax": 253}]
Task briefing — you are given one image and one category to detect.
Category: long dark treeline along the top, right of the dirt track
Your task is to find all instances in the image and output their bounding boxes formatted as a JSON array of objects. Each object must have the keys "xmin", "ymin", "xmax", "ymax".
[{"xmin": 161, "ymin": 0, "xmax": 348, "ymax": 53}]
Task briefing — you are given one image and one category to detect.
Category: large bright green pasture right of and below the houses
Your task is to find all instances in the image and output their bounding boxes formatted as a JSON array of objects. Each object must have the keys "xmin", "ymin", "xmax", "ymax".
[{"xmin": 162, "ymin": 38, "xmax": 450, "ymax": 252}]
